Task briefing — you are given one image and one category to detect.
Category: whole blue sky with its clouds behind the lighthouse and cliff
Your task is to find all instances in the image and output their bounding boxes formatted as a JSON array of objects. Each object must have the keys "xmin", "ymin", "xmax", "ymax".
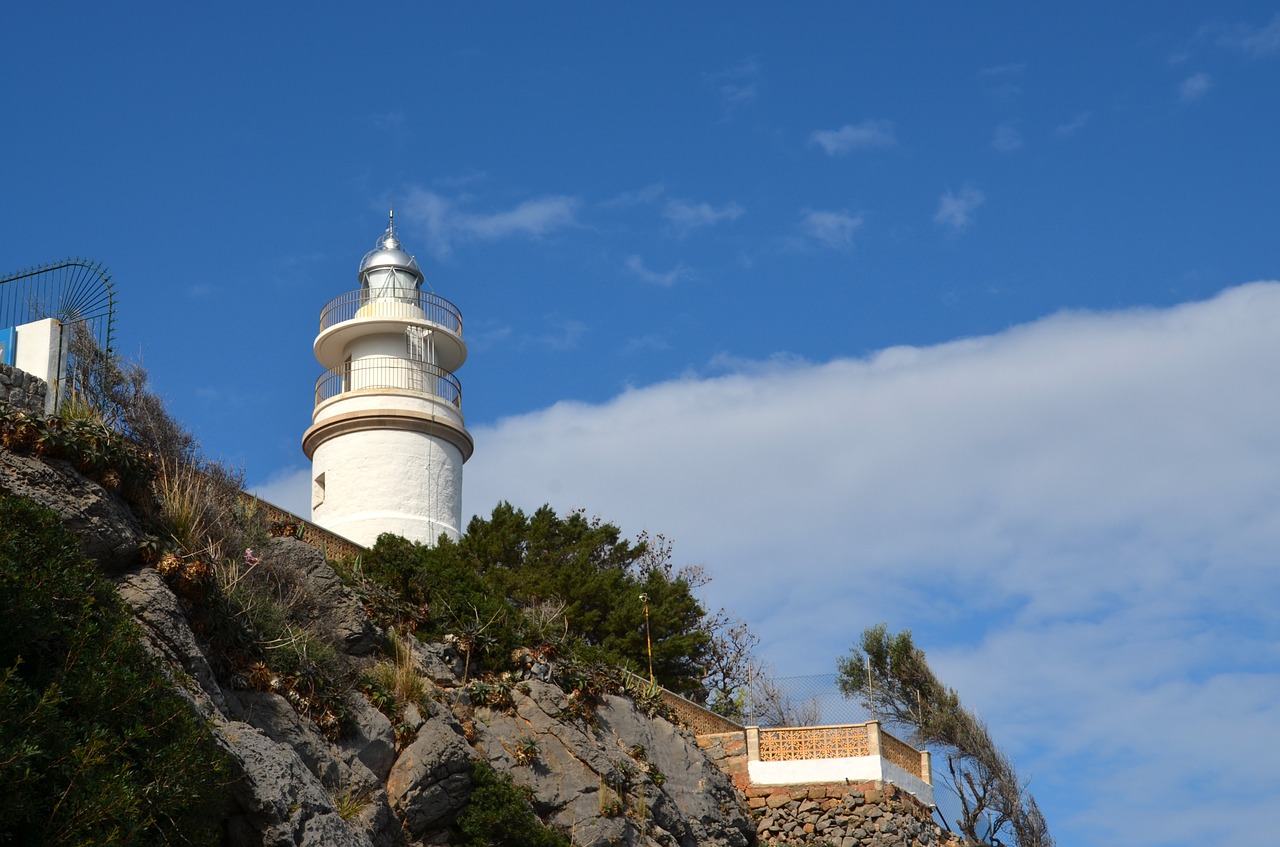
[{"xmin": 0, "ymin": 3, "xmax": 1280, "ymax": 847}]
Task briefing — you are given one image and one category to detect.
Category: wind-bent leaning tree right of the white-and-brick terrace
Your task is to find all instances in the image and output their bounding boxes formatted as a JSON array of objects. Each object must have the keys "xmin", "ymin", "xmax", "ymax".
[{"xmin": 836, "ymin": 623, "xmax": 1053, "ymax": 847}]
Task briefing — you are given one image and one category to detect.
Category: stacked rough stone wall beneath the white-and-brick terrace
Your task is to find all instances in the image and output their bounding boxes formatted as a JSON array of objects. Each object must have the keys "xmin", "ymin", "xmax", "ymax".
[{"xmin": 744, "ymin": 782, "xmax": 964, "ymax": 847}]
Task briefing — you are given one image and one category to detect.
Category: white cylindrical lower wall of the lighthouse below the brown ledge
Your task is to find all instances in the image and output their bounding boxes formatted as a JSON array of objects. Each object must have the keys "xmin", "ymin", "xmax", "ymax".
[{"xmin": 311, "ymin": 429, "xmax": 462, "ymax": 546}]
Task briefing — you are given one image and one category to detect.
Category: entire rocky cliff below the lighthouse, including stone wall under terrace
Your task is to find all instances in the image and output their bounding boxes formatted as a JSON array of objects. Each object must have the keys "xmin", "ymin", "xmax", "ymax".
[{"xmin": 0, "ymin": 417, "xmax": 962, "ymax": 847}]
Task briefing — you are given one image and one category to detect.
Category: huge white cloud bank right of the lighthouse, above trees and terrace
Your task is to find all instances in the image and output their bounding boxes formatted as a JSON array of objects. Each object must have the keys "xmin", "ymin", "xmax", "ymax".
[{"xmin": 466, "ymin": 283, "xmax": 1280, "ymax": 847}]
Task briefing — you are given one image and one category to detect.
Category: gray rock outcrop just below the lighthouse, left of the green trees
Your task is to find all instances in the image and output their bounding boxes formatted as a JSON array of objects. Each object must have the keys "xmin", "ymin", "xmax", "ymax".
[{"xmin": 259, "ymin": 537, "xmax": 378, "ymax": 656}]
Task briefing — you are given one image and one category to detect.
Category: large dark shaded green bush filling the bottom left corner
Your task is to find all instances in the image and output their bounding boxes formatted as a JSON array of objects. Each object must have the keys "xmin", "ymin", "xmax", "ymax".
[{"xmin": 0, "ymin": 495, "xmax": 230, "ymax": 844}]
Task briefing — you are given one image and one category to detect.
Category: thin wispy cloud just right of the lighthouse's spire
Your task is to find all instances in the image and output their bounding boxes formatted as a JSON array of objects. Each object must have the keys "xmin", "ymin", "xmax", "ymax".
[{"xmin": 403, "ymin": 188, "xmax": 581, "ymax": 258}]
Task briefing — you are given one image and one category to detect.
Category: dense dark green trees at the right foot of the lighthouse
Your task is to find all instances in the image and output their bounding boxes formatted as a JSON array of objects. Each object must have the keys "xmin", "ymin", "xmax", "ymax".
[{"xmin": 362, "ymin": 503, "xmax": 737, "ymax": 700}]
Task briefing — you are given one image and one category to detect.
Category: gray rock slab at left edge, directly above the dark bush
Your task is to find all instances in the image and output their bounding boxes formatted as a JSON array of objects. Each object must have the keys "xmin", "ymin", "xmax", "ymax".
[{"xmin": 0, "ymin": 448, "xmax": 142, "ymax": 572}]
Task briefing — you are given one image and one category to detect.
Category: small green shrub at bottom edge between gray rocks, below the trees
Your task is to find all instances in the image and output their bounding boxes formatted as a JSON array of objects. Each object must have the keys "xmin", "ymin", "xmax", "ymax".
[{"xmin": 458, "ymin": 760, "xmax": 571, "ymax": 847}]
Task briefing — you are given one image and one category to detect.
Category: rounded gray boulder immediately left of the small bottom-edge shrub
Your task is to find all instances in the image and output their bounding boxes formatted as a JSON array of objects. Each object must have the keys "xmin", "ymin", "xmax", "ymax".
[{"xmin": 387, "ymin": 716, "xmax": 472, "ymax": 837}]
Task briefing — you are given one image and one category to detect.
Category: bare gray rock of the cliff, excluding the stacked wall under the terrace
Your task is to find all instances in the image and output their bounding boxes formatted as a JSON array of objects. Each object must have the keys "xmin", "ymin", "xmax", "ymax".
[{"xmin": 0, "ymin": 450, "xmax": 773, "ymax": 847}]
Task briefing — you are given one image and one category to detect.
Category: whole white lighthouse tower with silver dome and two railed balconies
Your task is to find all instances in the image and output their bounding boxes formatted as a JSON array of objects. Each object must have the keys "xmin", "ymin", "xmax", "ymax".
[{"xmin": 302, "ymin": 212, "xmax": 474, "ymax": 546}]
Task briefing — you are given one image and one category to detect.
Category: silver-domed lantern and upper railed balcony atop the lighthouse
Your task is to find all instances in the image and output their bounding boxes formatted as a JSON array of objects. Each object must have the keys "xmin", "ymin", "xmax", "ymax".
[{"xmin": 315, "ymin": 215, "xmax": 467, "ymax": 374}]
